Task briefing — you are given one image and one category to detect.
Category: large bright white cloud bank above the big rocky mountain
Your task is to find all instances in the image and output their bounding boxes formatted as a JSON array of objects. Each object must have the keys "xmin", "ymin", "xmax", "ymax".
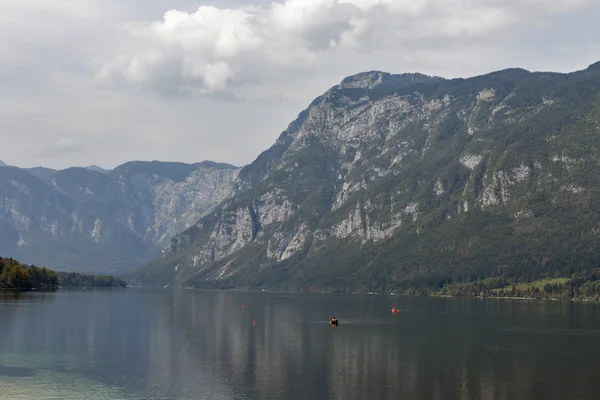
[{"xmin": 99, "ymin": 0, "xmax": 589, "ymax": 96}]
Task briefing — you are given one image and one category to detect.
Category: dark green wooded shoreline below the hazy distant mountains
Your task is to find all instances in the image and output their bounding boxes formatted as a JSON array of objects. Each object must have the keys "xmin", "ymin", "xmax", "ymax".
[{"xmin": 0, "ymin": 258, "xmax": 127, "ymax": 290}]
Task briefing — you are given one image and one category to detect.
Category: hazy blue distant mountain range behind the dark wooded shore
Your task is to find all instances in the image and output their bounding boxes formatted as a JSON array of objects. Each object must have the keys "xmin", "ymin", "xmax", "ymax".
[{"xmin": 0, "ymin": 162, "xmax": 239, "ymax": 273}]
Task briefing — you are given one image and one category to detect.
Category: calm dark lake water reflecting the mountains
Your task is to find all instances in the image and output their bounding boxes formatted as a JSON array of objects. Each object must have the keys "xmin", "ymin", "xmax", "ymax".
[{"xmin": 0, "ymin": 289, "xmax": 600, "ymax": 400}]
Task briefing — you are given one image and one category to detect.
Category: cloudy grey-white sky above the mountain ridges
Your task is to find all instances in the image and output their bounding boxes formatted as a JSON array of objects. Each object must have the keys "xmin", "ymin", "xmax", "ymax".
[{"xmin": 0, "ymin": 0, "xmax": 600, "ymax": 168}]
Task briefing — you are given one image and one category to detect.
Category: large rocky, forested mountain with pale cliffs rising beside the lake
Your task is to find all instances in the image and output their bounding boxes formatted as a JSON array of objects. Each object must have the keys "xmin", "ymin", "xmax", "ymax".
[{"xmin": 137, "ymin": 63, "xmax": 600, "ymax": 292}]
